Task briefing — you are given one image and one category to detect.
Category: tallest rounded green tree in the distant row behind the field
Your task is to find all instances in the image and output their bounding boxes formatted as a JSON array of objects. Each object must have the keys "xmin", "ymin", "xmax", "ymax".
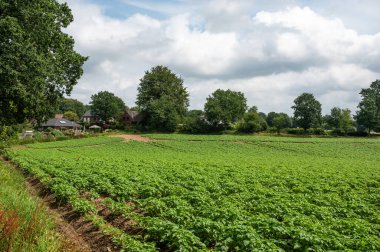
[{"xmin": 136, "ymin": 66, "xmax": 189, "ymax": 132}]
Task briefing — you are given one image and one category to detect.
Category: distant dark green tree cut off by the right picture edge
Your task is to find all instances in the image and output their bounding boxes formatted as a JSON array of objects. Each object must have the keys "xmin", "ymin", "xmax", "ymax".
[{"xmin": 356, "ymin": 80, "xmax": 380, "ymax": 133}]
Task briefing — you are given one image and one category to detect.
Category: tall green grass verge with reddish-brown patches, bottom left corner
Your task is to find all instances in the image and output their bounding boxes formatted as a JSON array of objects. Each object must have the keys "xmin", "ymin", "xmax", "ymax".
[{"xmin": 0, "ymin": 161, "xmax": 61, "ymax": 252}]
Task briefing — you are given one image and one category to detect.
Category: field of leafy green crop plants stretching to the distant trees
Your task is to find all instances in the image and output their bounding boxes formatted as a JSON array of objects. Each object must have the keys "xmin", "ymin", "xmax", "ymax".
[{"xmin": 7, "ymin": 134, "xmax": 380, "ymax": 251}]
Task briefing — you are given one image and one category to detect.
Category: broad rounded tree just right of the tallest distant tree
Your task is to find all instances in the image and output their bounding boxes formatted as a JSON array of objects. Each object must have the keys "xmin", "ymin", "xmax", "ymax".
[{"xmin": 204, "ymin": 89, "xmax": 247, "ymax": 129}]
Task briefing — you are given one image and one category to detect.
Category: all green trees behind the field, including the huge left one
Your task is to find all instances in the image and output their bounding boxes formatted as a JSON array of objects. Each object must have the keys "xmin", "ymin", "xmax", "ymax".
[{"xmin": 0, "ymin": 0, "xmax": 380, "ymax": 137}]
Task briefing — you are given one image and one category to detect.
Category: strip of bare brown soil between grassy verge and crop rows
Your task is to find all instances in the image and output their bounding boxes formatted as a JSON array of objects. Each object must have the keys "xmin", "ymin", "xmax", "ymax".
[{"xmin": 0, "ymin": 156, "xmax": 119, "ymax": 252}]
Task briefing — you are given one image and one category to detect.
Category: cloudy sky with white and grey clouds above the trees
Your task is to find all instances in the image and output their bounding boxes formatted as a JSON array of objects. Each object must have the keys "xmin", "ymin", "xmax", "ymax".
[{"xmin": 60, "ymin": 0, "xmax": 380, "ymax": 114}]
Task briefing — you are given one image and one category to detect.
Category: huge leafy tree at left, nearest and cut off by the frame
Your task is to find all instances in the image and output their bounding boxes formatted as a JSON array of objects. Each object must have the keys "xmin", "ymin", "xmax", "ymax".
[{"xmin": 0, "ymin": 0, "xmax": 87, "ymax": 125}]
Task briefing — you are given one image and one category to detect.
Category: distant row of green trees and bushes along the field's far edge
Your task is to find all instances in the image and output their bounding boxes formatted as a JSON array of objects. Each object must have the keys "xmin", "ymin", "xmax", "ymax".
[{"xmin": 55, "ymin": 66, "xmax": 380, "ymax": 135}]
